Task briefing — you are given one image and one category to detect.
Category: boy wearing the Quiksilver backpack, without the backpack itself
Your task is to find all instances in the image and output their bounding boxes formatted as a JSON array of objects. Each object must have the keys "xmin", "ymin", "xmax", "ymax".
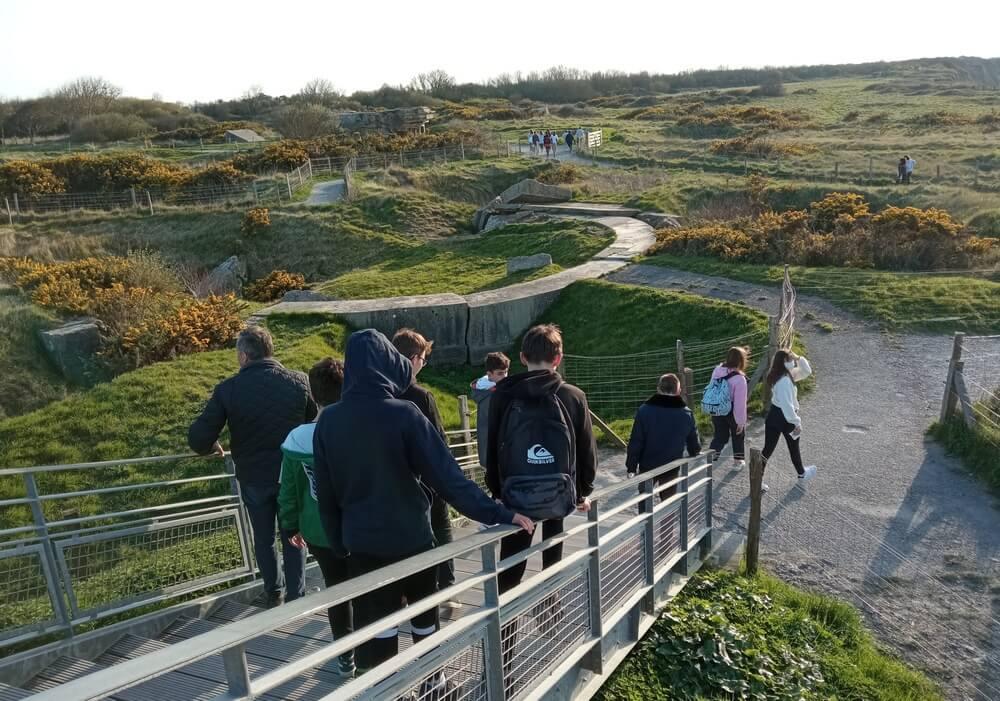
[{"xmin": 486, "ymin": 324, "xmax": 597, "ymax": 593}]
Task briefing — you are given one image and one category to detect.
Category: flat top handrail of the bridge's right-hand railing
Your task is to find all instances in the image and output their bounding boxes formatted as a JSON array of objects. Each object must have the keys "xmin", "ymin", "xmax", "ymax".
[{"xmin": 23, "ymin": 454, "xmax": 710, "ymax": 701}]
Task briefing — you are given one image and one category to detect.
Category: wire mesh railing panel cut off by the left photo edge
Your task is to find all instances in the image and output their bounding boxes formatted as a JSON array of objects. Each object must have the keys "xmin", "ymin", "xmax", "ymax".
[{"xmin": 0, "ymin": 545, "xmax": 56, "ymax": 638}]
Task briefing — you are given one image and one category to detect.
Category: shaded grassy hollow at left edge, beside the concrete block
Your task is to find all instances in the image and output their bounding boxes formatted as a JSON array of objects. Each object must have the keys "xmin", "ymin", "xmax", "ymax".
[{"xmin": 0, "ymin": 289, "xmax": 69, "ymax": 418}]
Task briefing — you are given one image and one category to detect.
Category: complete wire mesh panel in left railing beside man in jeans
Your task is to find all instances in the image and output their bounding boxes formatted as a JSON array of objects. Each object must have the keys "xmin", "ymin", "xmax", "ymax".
[{"xmin": 55, "ymin": 511, "xmax": 249, "ymax": 612}]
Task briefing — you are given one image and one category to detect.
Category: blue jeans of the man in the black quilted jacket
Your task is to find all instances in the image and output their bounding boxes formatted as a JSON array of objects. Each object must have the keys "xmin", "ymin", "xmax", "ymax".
[{"xmin": 240, "ymin": 482, "xmax": 306, "ymax": 601}]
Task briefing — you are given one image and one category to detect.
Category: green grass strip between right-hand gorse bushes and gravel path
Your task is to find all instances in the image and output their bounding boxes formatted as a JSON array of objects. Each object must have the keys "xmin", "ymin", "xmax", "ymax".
[{"xmin": 642, "ymin": 254, "xmax": 1000, "ymax": 333}]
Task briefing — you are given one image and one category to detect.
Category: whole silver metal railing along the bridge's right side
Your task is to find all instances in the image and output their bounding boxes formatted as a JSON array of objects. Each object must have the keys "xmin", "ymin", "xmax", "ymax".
[{"xmin": 21, "ymin": 455, "xmax": 713, "ymax": 701}]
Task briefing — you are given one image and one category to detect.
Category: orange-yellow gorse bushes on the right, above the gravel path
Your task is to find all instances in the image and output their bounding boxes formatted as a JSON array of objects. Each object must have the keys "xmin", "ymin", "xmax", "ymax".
[{"xmin": 652, "ymin": 187, "xmax": 997, "ymax": 270}]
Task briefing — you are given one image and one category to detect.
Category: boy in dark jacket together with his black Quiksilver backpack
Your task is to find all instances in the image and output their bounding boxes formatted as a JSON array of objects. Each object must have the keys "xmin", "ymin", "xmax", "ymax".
[{"xmin": 486, "ymin": 324, "xmax": 597, "ymax": 593}]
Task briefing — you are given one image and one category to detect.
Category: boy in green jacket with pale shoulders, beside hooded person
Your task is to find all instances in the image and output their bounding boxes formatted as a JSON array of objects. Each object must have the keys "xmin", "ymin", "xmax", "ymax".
[{"xmin": 278, "ymin": 358, "xmax": 354, "ymax": 677}]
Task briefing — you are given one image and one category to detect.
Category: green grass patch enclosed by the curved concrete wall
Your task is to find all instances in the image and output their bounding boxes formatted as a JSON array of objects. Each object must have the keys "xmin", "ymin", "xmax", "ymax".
[{"xmin": 319, "ymin": 222, "xmax": 614, "ymax": 299}]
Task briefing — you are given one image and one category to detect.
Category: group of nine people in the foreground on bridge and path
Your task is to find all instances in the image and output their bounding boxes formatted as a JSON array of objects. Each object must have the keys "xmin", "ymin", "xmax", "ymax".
[{"xmin": 188, "ymin": 324, "xmax": 815, "ymax": 693}]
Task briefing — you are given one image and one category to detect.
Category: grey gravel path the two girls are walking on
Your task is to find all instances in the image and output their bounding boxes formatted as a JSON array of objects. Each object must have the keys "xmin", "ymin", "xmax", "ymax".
[{"xmin": 610, "ymin": 265, "xmax": 1000, "ymax": 699}]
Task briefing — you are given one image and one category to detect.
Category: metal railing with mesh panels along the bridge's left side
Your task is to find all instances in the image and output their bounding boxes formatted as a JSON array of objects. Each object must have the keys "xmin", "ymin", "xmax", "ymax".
[{"xmin": 0, "ymin": 429, "xmax": 483, "ymax": 647}]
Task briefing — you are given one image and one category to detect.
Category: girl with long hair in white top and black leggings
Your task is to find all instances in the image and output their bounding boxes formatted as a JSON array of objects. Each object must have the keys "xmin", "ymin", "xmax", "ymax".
[{"xmin": 761, "ymin": 350, "xmax": 816, "ymax": 491}]
